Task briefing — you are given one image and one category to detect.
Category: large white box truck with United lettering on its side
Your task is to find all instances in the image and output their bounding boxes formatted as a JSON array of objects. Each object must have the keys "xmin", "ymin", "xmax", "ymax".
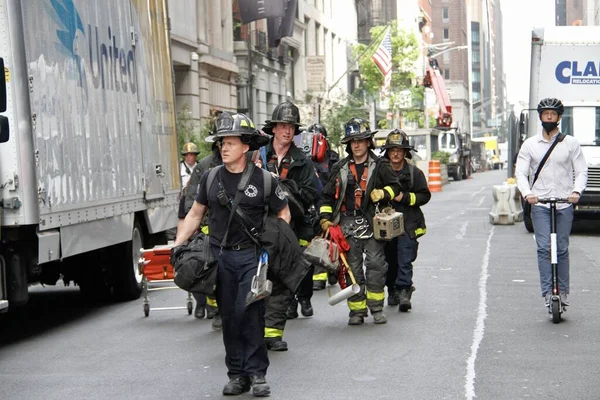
[{"xmin": 0, "ymin": 0, "xmax": 181, "ymax": 310}]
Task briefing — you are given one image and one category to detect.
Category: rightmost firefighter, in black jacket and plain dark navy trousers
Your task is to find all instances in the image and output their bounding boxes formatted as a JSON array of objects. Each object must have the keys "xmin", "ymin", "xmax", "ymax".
[{"xmin": 383, "ymin": 129, "xmax": 431, "ymax": 312}]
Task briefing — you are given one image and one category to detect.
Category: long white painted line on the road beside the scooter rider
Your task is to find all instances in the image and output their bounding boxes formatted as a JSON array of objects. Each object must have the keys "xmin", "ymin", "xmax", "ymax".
[{"xmin": 465, "ymin": 226, "xmax": 495, "ymax": 400}]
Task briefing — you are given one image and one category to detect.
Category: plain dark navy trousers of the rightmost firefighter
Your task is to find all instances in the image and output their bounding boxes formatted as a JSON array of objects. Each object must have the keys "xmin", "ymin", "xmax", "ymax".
[{"xmin": 385, "ymin": 231, "xmax": 419, "ymax": 292}]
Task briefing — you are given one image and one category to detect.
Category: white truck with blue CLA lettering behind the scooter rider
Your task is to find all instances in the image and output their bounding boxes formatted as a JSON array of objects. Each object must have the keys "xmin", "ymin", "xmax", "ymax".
[{"xmin": 524, "ymin": 26, "xmax": 600, "ymax": 232}]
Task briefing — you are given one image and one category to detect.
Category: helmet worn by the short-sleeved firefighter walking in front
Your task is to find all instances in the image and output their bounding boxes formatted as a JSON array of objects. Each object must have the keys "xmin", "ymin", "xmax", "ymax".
[{"xmin": 212, "ymin": 112, "xmax": 269, "ymax": 150}]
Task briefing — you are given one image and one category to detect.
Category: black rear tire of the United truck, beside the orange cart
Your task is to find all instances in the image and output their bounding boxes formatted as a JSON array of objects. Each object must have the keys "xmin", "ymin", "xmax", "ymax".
[{"xmin": 115, "ymin": 221, "xmax": 144, "ymax": 300}]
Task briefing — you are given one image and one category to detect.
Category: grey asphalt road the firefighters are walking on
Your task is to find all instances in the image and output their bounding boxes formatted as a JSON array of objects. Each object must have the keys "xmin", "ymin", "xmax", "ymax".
[{"xmin": 0, "ymin": 171, "xmax": 600, "ymax": 400}]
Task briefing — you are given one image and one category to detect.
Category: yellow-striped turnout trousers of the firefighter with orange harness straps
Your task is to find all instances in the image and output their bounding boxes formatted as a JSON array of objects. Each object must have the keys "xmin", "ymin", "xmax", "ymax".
[{"xmin": 346, "ymin": 237, "xmax": 388, "ymax": 316}]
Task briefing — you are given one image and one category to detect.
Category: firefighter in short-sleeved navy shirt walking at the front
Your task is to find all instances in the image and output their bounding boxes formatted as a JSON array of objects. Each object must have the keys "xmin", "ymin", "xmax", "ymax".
[{"xmin": 174, "ymin": 112, "xmax": 290, "ymax": 397}]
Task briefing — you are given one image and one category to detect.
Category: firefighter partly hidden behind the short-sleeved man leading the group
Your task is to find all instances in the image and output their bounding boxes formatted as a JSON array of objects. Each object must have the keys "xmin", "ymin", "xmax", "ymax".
[{"xmin": 261, "ymin": 101, "xmax": 317, "ymax": 351}]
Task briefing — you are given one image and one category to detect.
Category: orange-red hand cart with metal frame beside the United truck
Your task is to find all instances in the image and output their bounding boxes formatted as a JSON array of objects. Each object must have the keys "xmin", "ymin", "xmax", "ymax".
[{"xmin": 138, "ymin": 246, "xmax": 194, "ymax": 317}]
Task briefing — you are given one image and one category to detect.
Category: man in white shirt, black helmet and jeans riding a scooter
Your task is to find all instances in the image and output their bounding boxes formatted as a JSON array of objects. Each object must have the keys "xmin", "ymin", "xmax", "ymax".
[{"xmin": 515, "ymin": 98, "xmax": 588, "ymax": 307}]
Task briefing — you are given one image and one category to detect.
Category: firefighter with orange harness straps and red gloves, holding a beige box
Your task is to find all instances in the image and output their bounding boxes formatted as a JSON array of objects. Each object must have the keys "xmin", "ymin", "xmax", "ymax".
[{"xmin": 319, "ymin": 118, "xmax": 401, "ymax": 325}]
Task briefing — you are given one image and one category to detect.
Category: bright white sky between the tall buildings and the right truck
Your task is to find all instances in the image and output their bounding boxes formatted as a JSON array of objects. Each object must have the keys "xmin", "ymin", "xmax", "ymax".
[{"xmin": 500, "ymin": 0, "xmax": 555, "ymax": 108}]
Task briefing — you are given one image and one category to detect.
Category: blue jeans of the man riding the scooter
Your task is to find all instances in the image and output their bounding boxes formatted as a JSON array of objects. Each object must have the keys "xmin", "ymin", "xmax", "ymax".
[{"xmin": 531, "ymin": 206, "xmax": 573, "ymax": 296}]
